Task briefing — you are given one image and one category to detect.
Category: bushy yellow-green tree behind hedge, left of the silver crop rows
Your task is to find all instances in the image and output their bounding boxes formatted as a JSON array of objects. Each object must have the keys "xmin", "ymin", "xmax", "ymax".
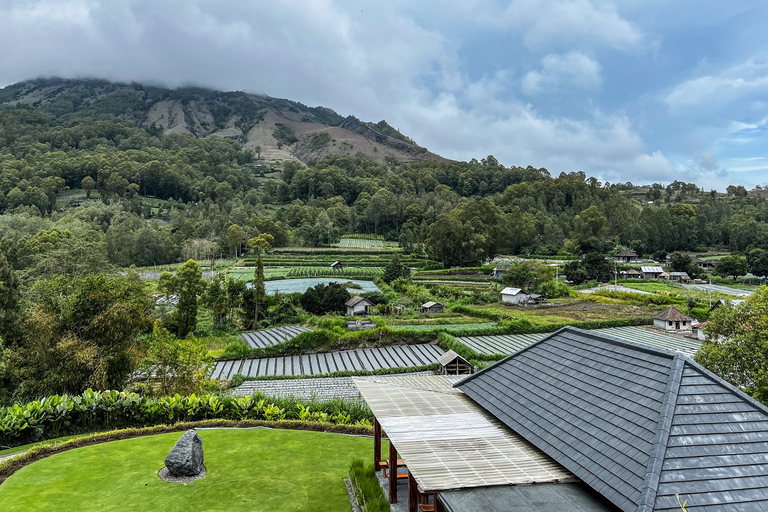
[{"xmin": 141, "ymin": 326, "xmax": 213, "ymax": 396}]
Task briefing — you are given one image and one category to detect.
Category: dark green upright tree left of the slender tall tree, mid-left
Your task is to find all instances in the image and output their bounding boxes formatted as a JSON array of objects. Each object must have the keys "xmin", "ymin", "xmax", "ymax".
[{"xmin": 158, "ymin": 260, "xmax": 206, "ymax": 336}]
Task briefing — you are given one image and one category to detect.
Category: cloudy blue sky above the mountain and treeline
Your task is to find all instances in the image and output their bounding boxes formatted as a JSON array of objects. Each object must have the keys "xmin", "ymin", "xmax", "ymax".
[{"xmin": 0, "ymin": 0, "xmax": 768, "ymax": 190}]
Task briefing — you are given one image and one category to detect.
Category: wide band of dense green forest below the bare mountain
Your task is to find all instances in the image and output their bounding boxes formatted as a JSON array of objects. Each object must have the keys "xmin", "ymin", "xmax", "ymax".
[{"xmin": 0, "ymin": 103, "xmax": 768, "ymax": 269}]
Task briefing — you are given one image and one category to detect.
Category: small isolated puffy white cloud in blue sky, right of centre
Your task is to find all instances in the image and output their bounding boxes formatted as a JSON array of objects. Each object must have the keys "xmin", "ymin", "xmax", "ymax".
[{"xmin": 521, "ymin": 51, "xmax": 602, "ymax": 95}]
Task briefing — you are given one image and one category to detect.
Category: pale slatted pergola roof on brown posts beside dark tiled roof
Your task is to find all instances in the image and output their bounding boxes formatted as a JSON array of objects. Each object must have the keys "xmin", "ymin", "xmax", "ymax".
[{"xmin": 354, "ymin": 376, "xmax": 577, "ymax": 512}]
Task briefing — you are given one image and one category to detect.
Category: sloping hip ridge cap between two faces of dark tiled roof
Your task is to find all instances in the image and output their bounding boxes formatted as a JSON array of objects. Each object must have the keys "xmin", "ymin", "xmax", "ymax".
[{"xmin": 637, "ymin": 353, "xmax": 687, "ymax": 512}]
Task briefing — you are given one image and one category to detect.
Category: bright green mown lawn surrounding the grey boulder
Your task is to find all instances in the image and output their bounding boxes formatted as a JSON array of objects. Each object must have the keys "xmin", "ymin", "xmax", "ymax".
[{"xmin": 0, "ymin": 429, "xmax": 388, "ymax": 512}]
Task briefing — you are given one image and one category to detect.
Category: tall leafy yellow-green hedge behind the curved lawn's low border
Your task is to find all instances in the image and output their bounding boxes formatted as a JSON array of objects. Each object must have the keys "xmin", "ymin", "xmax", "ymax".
[{"xmin": 0, "ymin": 389, "xmax": 373, "ymax": 447}]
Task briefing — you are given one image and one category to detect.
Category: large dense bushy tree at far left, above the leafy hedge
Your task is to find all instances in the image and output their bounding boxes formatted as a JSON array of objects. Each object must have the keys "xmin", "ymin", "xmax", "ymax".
[{"xmin": 12, "ymin": 275, "xmax": 152, "ymax": 398}]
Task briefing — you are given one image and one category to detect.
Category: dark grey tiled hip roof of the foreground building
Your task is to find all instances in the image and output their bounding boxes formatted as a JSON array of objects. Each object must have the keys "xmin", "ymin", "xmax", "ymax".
[{"xmin": 457, "ymin": 327, "xmax": 768, "ymax": 512}]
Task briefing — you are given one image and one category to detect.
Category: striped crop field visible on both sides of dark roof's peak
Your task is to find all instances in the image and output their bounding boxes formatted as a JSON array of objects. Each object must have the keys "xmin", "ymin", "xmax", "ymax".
[{"xmin": 456, "ymin": 327, "xmax": 701, "ymax": 356}]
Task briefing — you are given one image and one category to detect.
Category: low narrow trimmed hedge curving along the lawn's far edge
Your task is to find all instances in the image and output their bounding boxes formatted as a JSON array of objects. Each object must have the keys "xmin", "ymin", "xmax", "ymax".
[{"xmin": 0, "ymin": 420, "xmax": 373, "ymax": 483}]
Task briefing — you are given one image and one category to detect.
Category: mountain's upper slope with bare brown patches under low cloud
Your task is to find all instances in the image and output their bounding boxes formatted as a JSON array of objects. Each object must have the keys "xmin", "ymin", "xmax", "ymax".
[{"xmin": 0, "ymin": 78, "xmax": 446, "ymax": 163}]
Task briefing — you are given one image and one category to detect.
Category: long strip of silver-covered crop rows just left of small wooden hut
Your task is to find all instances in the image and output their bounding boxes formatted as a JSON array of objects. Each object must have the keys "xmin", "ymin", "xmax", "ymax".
[{"xmin": 211, "ymin": 344, "xmax": 445, "ymax": 379}]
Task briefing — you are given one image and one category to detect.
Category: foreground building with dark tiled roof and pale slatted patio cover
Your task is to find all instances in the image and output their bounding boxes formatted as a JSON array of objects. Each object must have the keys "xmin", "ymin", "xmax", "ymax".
[{"xmin": 353, "ymin": 327, "xmax": 768, "ymax": 512}]
